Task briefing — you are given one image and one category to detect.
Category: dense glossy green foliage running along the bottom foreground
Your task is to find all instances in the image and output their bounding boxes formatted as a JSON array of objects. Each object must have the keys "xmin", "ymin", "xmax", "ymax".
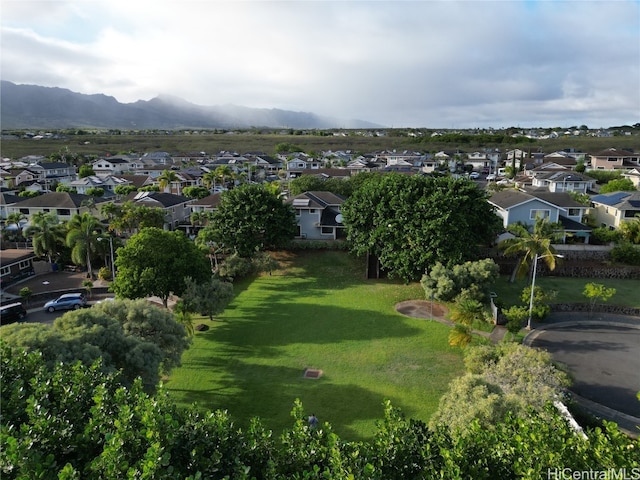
[{"xmin": 0, "ymin": 345, "xmax": 640, "ymax": 480}]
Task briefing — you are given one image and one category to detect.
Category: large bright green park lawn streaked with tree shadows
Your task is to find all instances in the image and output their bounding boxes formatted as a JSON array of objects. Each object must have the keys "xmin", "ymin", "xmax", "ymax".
[{"xmin": 166, "ymin": 251, "xmax": 464, "ymax": 440}]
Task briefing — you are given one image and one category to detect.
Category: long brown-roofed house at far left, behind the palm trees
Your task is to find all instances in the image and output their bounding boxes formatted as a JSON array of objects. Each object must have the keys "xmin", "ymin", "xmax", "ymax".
[{"xmin": 7, "ymin": 192, "xmax": 106, "ymax": 222}]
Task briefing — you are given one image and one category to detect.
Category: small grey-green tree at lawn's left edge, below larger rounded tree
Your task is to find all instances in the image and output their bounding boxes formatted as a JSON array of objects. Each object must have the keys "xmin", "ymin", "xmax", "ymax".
[{"xmin": 182, "ymin": 277, "xmax": 233, "ymax": 320}]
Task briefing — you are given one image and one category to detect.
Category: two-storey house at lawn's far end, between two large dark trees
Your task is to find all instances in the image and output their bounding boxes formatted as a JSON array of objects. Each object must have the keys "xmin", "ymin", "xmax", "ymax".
[{"xmin": 287, "ymin": 191, "xmax": 345, "ymax": 240}]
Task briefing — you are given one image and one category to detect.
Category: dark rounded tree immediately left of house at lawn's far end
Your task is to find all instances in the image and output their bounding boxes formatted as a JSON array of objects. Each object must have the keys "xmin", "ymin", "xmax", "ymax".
[{"xmin": 198, "ymin": 183, "xmax": 296, "ymax": 257}]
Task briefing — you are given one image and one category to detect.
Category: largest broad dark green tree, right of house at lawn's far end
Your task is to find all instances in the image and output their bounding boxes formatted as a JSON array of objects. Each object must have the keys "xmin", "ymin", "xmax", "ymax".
[{"xmin": 342, "ymin": 173, "xmax": 500, "ymax": 281}]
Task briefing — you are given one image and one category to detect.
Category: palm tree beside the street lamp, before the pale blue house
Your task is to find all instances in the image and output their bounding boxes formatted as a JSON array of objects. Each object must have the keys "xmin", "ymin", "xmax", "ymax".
[{"xmin": 498, "ymin": 217, "xmax": 564, "ymax": 282}]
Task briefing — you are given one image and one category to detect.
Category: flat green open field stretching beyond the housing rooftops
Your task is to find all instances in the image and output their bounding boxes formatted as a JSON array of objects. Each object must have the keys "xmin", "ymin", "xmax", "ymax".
[{"xmin": 0, "ymin": 130, "xmax": 640, "ymax": 159}]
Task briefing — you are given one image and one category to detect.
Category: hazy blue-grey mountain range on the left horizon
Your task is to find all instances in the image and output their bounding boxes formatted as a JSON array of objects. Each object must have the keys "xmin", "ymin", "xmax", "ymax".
[{"xmin": 0, "ymin": 80, "xmax": 380, "ymax": 130}]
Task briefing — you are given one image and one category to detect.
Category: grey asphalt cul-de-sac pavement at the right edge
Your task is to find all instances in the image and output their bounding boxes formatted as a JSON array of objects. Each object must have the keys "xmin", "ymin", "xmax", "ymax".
[{"xmin": 531, "ymin": 322, "xmax": 640, "ymax": 417}]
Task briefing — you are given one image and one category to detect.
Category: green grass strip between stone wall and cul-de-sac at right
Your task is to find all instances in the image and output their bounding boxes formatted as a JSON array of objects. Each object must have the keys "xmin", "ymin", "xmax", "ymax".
[{"xmin": 493, "ymin": 275, "xmax": 640, "ymax": 308}]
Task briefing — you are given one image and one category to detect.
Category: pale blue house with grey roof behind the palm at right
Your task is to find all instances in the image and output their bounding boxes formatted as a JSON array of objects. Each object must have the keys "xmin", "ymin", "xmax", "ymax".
[{"xmin": 488, "ymin": 189, "xmax": 592, "ymax": 243}]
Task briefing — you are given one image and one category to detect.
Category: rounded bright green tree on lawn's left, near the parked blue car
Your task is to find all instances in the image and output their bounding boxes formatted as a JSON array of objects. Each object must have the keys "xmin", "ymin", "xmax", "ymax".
[{"xmin": 111, "ymin": 227, "xmax": 211, "ymax": 307}]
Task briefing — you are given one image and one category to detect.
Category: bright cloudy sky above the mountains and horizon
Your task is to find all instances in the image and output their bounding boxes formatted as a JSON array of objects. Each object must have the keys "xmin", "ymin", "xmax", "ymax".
[{"xmin": 0, "ymin": 0, "xmax": 640, "ymax": 129}]
